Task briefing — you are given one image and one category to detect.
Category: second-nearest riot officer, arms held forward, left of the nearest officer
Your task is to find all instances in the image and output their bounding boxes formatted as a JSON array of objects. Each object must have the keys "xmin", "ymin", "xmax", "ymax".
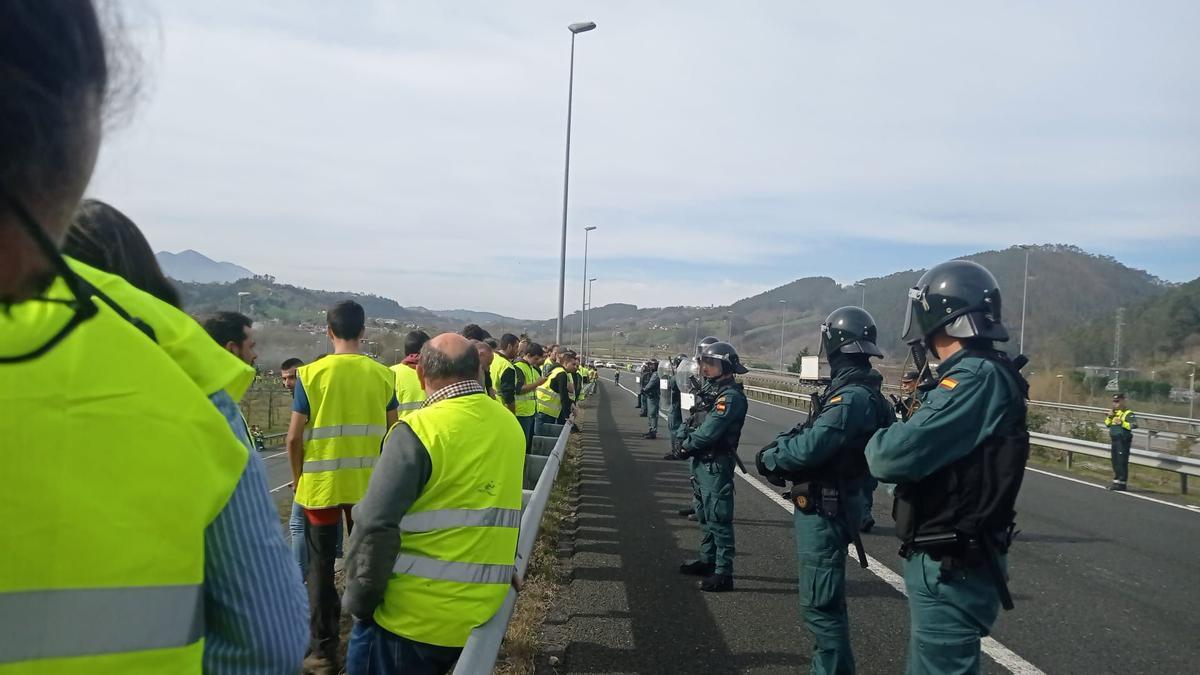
[{"xmin": 757, "ymin": 307, "xmax": 895, "ymax": 674}]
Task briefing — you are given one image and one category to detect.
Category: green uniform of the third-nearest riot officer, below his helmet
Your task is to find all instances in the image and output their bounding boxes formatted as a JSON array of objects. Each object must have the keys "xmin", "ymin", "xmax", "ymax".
[{"xmin": 682, "ymin": 375, "xmax": 748, "ymax": 577}]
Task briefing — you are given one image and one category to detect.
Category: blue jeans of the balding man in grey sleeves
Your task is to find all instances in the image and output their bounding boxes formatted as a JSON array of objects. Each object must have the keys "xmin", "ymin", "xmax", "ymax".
[{"xmin": 346, "ymin": 621, "xmax": 462, "ymax": 675}]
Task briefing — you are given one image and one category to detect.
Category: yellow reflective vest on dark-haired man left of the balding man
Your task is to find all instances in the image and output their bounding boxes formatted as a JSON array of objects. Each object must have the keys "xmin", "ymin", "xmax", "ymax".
[{"xmin": 296, "ymin": 354, "xmax": 396, "ymax": 509}]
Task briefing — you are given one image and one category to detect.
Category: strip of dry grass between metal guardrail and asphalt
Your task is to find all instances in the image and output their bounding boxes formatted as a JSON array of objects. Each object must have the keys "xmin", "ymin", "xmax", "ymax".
[{"xmin": 494, "ymin": 417, "xmax": 580, "ymax": 675}]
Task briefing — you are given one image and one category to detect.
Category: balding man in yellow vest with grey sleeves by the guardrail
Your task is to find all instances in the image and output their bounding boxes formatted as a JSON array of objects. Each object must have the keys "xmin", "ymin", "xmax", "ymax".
[{"xmin": 346, "ymin": 333, "xmax": 524, "ymax": 675}]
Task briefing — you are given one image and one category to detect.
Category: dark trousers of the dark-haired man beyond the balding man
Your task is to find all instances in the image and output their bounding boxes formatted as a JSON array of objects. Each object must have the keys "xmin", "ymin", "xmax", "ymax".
[{"xmin": 304, "ymin": 506, "xmax": 354, "ymax": 663}]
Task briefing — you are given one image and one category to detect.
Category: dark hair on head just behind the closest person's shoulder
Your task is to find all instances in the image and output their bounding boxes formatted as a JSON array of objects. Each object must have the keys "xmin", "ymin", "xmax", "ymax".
[{"xmin": 62, "ymin": 199, "xmax": 181, "ymax": 307}]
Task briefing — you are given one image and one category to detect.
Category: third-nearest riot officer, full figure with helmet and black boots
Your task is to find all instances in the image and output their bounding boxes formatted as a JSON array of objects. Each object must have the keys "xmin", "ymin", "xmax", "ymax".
[{"xmin": 679, "ymin": 342, "xmax": 748, "ymax": 592}]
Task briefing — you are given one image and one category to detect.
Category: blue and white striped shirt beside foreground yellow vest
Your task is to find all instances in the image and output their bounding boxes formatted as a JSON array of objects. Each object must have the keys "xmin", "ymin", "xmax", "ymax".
[{"xmin": 204, "ymin": 392, "xmax": 308, "ymax": 675}]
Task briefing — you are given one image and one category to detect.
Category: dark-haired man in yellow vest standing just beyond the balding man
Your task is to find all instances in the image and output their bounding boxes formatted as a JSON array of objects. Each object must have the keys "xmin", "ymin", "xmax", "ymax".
[{"xmin": 288, "ymin": 300, "xmax": 398, "ymax": 671}]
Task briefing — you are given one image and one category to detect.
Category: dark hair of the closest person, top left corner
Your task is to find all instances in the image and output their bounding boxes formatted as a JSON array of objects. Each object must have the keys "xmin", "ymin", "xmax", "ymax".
[{"xmin": 0, "ymin": 0, "xmax": 109, "ymax": 210}]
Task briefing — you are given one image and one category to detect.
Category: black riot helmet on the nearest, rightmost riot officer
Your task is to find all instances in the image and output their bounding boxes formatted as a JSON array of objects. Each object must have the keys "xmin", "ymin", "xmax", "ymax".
[{"xmin": 901, "ymin": 261, "xmax": 1008, "ymax": 345}]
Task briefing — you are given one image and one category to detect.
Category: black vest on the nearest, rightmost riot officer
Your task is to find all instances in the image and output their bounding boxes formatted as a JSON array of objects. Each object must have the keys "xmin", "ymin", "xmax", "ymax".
[{"xmin": 892, "ymin": 351, "xmax": 1030, "ymax": 546}]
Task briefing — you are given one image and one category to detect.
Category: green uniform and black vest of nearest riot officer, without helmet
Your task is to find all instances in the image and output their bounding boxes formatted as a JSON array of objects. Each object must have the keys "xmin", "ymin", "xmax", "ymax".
[{"xmin": 866, "ymin": 350, "xmax": 1028, "ymax": 674}]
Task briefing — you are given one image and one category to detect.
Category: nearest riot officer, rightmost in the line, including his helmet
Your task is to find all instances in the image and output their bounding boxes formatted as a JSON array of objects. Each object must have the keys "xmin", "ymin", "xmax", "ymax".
[{"xmin": 866, "ymin": 261, "xmax": 1030, "ymax": 674}]
